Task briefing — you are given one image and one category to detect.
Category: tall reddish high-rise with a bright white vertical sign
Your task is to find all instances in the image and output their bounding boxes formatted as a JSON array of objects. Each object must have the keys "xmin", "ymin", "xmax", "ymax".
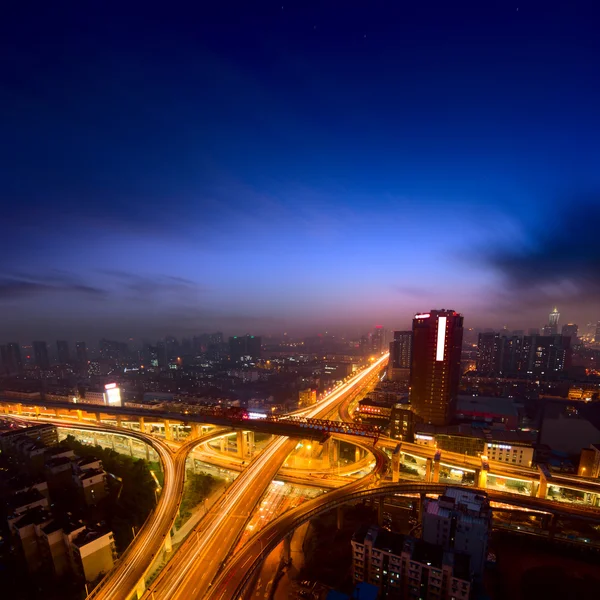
[{"xmin": 410, "ymin": 309, "xmax": 463, "ymax": 425}]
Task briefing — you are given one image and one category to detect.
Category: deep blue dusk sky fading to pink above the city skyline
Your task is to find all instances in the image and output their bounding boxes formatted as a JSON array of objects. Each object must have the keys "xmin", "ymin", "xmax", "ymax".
[{"xmin": 0, "ymin": 0, "xmax": 600, "ymax": 342}]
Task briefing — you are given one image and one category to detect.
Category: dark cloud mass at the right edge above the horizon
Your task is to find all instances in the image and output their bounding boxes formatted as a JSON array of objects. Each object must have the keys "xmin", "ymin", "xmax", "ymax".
[{"xmin": 485, "ymin": 193, "xmax": 600, "ymax": 303}]
